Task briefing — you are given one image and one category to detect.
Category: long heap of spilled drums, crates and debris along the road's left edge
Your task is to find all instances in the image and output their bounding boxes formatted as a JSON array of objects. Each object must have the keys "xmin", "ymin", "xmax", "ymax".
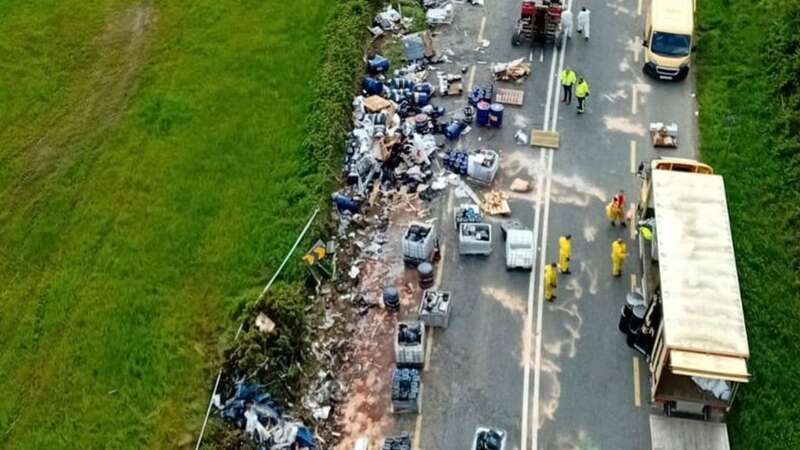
[{"xmin": 205, "ymin": 0, "xmax": 544, "ymax": 450}]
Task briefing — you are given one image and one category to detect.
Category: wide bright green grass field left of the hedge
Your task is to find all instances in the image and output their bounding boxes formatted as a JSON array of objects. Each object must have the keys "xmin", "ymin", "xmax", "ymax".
[{"xmin": 0, "ymin": 0, "xmax": 330, "ymax": 449}]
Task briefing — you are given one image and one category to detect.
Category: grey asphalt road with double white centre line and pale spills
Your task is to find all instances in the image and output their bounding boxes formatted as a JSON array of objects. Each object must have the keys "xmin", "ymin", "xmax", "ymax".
[{"xmin": 400, "ymin": 0, "xmax": 697, "ymax": 450}]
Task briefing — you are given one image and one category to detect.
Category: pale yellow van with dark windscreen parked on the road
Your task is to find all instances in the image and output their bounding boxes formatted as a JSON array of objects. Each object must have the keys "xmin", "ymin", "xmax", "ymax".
[{"xmin": 642, "ymin": 0, "xmax": 694, "ymax": 80}]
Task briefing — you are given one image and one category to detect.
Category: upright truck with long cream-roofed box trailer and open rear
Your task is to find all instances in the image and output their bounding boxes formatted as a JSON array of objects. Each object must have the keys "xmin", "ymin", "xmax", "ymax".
[{"xmin": 637, "ymin": 158, "xmax": 750, "ymax": 448}]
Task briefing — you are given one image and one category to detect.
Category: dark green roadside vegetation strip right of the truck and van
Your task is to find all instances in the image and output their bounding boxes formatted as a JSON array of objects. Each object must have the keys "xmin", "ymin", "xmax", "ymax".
[{"xmin": 696, "ymin": 0, "xmax": 800, "ymax": 450}]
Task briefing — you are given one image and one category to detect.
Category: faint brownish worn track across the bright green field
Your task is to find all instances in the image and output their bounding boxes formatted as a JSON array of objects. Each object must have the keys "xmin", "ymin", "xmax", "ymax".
[{"xmin": 13, "ymin": 2, "xmax": 157, "ymax": 198}]
